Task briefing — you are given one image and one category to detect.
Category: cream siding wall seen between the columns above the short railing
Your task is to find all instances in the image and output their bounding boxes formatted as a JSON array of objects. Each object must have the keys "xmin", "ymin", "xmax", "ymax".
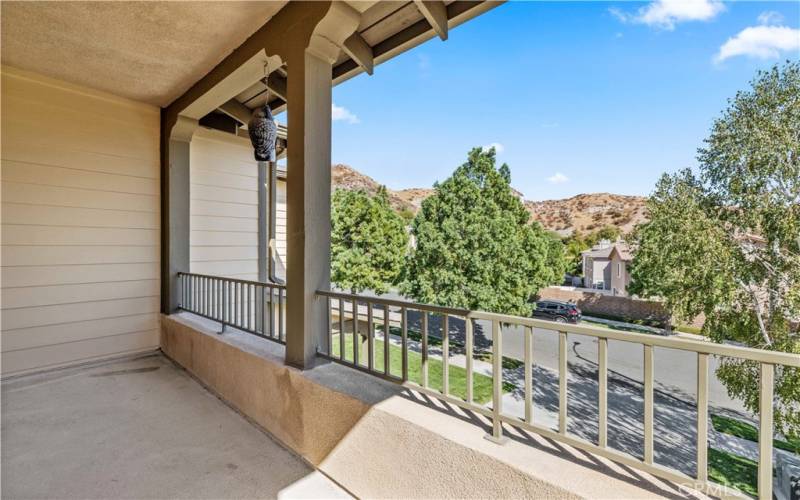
[{"xmin": 189, "ymin": 127, "xmax": 286, "ymax": 280}]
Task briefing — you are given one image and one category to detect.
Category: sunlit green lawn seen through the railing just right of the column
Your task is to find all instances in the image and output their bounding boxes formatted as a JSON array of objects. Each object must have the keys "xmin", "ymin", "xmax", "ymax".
[{"xmin": 332, "ymin": 329, "xmax": 510, "ymax": 404}]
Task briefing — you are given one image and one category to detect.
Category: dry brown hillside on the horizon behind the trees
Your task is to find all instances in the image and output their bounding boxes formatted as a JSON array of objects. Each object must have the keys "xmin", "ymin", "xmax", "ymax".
[{"xmin": 331, "ymin": 164, "xmax": 647, "ymax": 236}]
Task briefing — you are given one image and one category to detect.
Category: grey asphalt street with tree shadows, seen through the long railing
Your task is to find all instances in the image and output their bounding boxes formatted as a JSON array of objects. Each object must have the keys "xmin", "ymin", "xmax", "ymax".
[{"xmin": 332, "ymin": 296, "xmax": 779, "ymax": 475}]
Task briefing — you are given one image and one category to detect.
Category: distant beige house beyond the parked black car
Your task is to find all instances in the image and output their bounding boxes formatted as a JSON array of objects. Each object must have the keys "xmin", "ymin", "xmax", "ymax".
[{"xmin": 581, "ymin": 240, "xmax": 633, "ymax": 296}]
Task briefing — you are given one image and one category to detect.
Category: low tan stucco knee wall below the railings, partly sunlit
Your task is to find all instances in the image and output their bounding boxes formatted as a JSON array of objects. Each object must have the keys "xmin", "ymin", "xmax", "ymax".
[{"xmin": 161, "ymin": 316, "xmax": 576, "ymax": 498}]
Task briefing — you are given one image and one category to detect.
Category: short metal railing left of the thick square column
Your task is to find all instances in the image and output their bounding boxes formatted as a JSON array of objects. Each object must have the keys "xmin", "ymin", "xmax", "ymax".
[{"xmin": 178, "ymin": 273, "xmax": 286, "ymax": 344}]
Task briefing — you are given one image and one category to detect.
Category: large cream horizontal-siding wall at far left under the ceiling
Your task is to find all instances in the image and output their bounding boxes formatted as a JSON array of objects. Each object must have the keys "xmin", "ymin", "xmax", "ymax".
[{"xmin": 0, "ymin": 67, "xmax": 159, "ymax": 375}]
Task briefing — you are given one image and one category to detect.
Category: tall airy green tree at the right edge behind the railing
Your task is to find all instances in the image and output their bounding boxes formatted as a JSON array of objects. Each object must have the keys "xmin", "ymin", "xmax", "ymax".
[{"xmin": 630, "ymin": 62, "xmax": 800, "ymax": 435}]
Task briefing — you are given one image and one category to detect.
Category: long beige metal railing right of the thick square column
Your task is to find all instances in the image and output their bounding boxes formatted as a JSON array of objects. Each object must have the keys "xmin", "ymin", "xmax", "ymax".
[{"xmin": 317, "ymin": 291, "xmax": 800, "ymax": 500}]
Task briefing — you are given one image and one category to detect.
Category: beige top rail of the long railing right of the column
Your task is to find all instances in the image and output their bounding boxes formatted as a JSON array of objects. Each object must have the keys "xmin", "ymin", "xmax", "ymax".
[{"xmin": 317, "ymin": 290, "xmax": 800, "ymax": 368}]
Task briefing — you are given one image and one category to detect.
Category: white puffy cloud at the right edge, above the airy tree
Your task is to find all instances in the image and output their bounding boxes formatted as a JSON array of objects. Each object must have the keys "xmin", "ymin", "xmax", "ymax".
[{"xmin": 714, "ymin": 26, "xmax": 800, "ymax": 62}]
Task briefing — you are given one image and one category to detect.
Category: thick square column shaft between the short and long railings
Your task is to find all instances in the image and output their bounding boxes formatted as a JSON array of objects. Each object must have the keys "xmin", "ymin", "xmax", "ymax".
[{"xmin": 286, "ymin": 50, "xmax": 332, "ymax": 368}]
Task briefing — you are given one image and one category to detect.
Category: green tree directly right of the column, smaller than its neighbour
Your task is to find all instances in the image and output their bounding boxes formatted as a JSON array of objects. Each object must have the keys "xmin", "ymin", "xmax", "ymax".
[{"xmin": 331, "ymin": 187, "xmax": 408, "ymax": 294}]
